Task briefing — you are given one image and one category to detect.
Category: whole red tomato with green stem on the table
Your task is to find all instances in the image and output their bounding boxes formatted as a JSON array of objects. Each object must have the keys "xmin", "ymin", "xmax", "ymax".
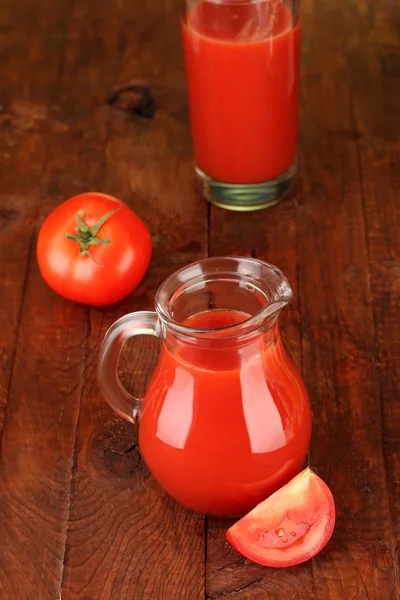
[{"xmin": 37, "ymin": 192, "xmax": 151, "ymax": 306}]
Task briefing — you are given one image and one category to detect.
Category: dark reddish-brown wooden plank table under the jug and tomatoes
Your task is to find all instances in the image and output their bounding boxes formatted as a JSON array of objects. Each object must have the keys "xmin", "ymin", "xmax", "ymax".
[{"xmin": 0, "ymin": 0, "xmax": 400, "ymax": 600}]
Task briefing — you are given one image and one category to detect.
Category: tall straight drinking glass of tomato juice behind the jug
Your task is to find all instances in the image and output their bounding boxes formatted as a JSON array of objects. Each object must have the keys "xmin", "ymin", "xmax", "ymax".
[{"xmin": 181, "ymin": 0, "xmax": 300, "ymax": 211}]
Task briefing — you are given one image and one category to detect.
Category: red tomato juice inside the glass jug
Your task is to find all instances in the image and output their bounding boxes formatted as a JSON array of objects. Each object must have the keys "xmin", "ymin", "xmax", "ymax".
[{"xmin": 139, "ymin": 310, "xmax": 311, "ymax": 515}]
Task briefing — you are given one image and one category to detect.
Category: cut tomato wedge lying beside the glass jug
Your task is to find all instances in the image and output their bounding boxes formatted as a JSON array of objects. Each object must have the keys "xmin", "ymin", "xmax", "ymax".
[{"xmin": 226, "ymin": 468, "xmax": 335, "ymax": 567}]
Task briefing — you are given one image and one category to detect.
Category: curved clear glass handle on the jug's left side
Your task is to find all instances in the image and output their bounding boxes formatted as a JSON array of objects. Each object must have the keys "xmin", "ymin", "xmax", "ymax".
[{"xmin": 97, "ymin": 311, "xmax": 162, "ymax": 423}]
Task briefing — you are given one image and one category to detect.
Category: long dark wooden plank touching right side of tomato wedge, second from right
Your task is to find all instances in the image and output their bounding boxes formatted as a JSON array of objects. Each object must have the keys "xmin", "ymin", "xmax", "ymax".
[{"xmin": 298, "ymin": 2, "xmax": 397, "ymax": 600}]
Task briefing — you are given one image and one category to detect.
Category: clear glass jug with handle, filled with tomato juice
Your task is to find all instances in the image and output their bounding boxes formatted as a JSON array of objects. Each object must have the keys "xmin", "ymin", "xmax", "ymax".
[{"xmin": 98, "ymin": 257, "xmax": 311, "ymax": 516}]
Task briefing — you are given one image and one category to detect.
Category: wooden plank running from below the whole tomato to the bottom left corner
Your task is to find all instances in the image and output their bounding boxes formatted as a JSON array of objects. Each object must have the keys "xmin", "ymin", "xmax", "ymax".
[{"xmin": 0, "ymin": 256, "xmax": 85, "ymax": 600}]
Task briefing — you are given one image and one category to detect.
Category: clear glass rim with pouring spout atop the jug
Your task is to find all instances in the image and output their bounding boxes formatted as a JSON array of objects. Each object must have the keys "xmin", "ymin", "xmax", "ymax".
[{"xmin": 155, "ymin": 256, "xmax": 293, "ymax": 339}]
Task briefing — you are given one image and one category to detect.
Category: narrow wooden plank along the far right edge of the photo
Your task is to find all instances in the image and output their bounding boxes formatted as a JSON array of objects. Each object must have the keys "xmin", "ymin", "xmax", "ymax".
[{"xmin": 351, "ymin": 15, "xmax": 400, "ymax": 581}]
